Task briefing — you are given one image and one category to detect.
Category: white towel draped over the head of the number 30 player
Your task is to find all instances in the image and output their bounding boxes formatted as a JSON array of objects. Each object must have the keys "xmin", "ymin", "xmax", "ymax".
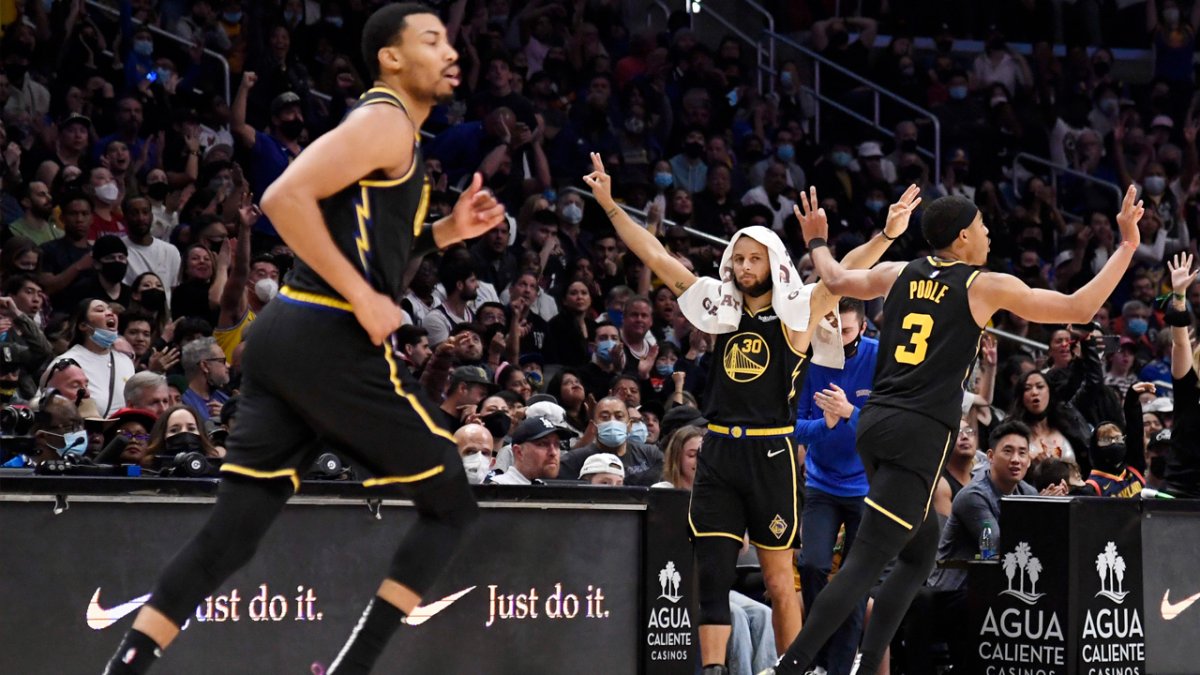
[{"xmin": 679, "ymin": 225, "xmax": 846, "ymax": 369}]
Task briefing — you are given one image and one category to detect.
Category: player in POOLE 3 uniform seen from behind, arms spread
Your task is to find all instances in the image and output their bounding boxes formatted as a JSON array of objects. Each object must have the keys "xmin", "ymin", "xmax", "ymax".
[{"xmin": 768, "ymin": 186, "xmax": 1142, "ymax": 675}]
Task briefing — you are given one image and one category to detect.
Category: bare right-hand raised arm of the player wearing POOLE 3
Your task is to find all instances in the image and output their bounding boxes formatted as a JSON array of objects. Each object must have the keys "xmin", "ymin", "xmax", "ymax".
[{"xmin": 971, "ymin": 185, "xmax": 1145, "ymax": 323}]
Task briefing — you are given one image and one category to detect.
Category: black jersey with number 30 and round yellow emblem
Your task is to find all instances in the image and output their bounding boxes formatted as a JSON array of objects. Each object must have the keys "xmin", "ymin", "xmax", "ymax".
[{"xmin": 704, "ymin": 306, "xmax": 809, "ymax": 428}]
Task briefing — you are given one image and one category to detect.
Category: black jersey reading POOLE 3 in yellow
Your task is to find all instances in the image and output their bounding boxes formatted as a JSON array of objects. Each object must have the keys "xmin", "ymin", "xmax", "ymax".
[{"xmin": 868, "ymin": 257, "xmax": 983, "ymax": 429}]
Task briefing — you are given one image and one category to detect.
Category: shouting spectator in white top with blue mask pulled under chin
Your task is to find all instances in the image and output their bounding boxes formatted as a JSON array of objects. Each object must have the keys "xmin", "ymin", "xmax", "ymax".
[{"xmin": 50, "ymin": 299, "xmax": 136, "ymax": 417}]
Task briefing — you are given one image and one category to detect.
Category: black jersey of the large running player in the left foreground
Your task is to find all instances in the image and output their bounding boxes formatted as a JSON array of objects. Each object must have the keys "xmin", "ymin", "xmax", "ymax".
[{"xmin": 288, "ymin": 86, "xmax": 430, "ymax": 303}]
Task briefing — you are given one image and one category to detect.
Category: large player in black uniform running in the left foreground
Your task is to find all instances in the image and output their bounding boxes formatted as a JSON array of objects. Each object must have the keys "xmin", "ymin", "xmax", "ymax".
[{"xmin": 98, "ymin": 4, "xmax": 504, "ymax": 675}]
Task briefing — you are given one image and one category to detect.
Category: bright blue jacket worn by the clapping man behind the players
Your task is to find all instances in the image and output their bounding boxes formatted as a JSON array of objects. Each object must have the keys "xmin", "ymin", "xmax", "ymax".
[{"xmin": 796, "ymin": 336, "xmax": 880, "ymax": 497}]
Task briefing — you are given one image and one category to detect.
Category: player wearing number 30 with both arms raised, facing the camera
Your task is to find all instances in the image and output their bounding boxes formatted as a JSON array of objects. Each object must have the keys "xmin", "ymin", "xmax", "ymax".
[{"xmin": 584, "ymin": 154, "xmax": 920, "ymax": 675}]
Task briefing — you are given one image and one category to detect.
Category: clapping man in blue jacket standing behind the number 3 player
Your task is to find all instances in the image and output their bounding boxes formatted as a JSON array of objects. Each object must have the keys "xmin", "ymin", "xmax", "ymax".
[{"xmin": 796, "ymin": 298, "xmax": 880, "ymax": 675}]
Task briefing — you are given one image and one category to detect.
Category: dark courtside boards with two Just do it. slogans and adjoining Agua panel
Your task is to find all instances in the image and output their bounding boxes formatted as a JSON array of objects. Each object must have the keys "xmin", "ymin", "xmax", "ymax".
[{"xmin": 0, "ymin": 487, "xmax": 698, "ymax": 675}]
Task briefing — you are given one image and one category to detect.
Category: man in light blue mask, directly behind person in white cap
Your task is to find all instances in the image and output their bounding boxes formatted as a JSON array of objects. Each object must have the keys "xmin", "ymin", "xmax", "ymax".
[{"xmin": 559, "ymin": 396, "xmax": 662, "ymax": 486}]
